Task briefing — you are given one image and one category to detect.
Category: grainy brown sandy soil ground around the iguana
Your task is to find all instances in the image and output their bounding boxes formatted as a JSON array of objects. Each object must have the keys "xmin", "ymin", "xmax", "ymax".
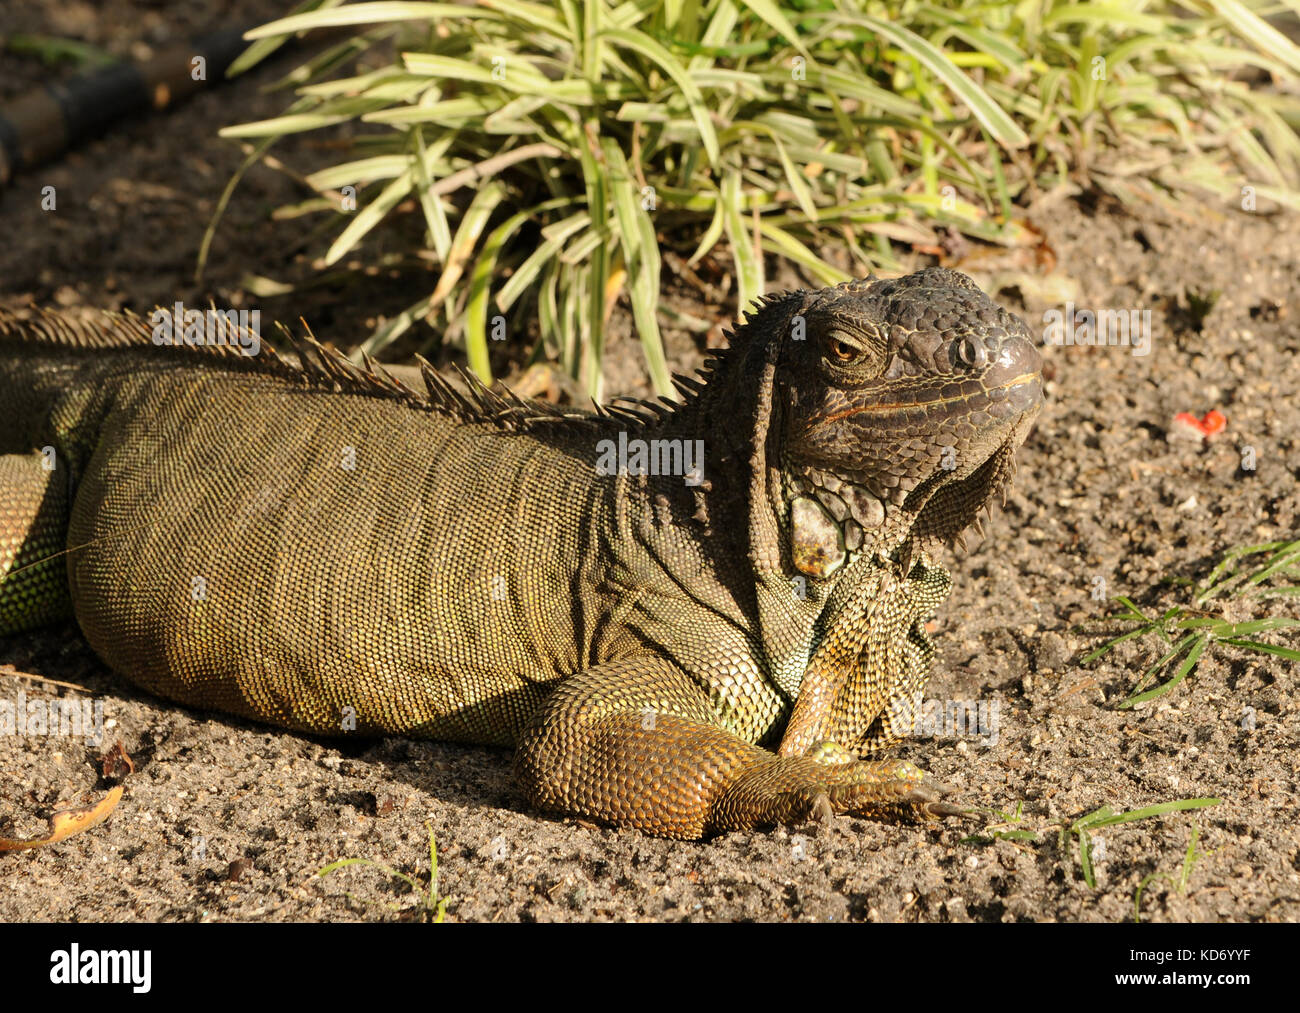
[{"xmin": 0, "ymin": 0, "xmax": 1300, "ymax": 921}]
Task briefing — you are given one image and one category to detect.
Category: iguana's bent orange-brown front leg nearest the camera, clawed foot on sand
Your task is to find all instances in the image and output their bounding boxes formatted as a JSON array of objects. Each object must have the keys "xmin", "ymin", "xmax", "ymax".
[{"xmin": 515, "ymin": 655, "xmax": 954, "ymax": 839}]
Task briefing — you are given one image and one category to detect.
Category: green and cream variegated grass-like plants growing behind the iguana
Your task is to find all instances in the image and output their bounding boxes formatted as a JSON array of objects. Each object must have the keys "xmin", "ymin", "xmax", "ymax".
[{"xmin": 200, "ymin": 0, "xmax": 1300, "ymax": 397}]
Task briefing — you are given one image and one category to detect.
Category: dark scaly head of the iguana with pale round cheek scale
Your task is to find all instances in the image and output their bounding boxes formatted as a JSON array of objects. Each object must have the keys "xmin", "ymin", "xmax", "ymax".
[{"xmin": 771, "ymin": 268, "xmax": 1043, "ymax": 577}]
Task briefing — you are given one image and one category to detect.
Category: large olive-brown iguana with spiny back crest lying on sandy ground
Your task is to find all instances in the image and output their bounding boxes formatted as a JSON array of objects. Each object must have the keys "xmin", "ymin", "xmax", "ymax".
[{"xmin": 0, "ymin": 268, "xmax": 1041, "ymax": 839}]
